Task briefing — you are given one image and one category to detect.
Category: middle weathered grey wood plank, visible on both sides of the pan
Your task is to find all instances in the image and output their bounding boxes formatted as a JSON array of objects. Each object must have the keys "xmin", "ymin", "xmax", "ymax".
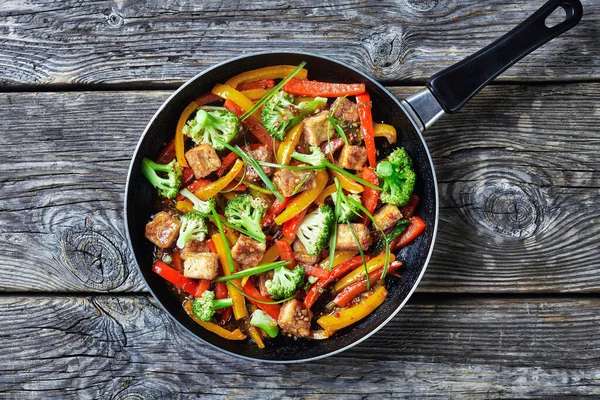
[{"xmin": 0, "ymin": 84, "xmax": 600, "ymax": 292}]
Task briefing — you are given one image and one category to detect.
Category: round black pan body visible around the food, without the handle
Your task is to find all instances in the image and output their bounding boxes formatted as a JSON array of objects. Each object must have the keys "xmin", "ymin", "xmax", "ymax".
[{"xmin": 125, "ymin": 53, "xmax": 437, "ymax": 362}]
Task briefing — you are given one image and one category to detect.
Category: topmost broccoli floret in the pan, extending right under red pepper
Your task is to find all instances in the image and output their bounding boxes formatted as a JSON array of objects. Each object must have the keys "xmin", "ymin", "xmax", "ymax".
[{"xmin": 262, "ymin": 92, "xmax": 327, "ymax": 141}]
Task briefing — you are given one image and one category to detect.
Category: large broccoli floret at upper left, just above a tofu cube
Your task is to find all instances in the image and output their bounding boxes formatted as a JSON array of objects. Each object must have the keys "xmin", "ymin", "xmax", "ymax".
[{"xmin": 183, "ymin": 109, "xmax": 240, "ymax": 150}]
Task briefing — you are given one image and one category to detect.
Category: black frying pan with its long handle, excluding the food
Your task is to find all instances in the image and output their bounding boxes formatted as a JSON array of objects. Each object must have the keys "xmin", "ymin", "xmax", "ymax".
[{"xmin": 125, "ymin": 0, "xmax": 583, "ymax": 362}]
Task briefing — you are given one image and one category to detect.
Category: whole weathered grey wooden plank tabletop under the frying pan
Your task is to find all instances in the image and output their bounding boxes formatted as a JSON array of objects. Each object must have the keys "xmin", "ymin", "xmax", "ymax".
[{"xmin": 0, "ymin": 0, "xmax": 600, "ymax": 399}]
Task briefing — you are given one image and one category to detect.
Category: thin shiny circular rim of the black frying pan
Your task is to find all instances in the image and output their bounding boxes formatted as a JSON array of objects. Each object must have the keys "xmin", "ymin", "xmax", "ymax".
[{"xmin": 123, "ymin": 50, "xmax": 439, "ymax": 364}]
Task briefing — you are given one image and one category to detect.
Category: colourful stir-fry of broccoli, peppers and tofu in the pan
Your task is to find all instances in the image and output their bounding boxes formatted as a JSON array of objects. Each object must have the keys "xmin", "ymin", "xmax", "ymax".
[{"xmin": 142, "ymin": 63, "xmax": 425, "ymax": 348}]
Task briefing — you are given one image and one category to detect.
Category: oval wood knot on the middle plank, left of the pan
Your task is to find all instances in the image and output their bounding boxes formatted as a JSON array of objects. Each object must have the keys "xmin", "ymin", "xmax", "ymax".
[{"xmin": 61, "ymin": 227, "xmax": 127, "ymax": 291}]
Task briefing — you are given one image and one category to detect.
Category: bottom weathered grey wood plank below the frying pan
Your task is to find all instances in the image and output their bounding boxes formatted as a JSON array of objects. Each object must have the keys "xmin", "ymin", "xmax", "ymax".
[{"xmin": 0, "ymin": 296, "xmax": 600, "ymax": 399}]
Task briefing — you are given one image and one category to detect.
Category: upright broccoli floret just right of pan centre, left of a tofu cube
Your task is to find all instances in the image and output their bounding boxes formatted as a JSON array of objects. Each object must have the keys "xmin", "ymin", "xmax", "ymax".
[{"xmin": 296, "ymin": 205, "xmax": 334, "ymax": 255}]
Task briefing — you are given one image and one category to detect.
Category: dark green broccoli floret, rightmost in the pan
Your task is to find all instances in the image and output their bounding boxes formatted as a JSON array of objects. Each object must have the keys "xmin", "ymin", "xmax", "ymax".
[{"xmin": 376, "ymin": 147, "xmax": 417, "ymax": 206}]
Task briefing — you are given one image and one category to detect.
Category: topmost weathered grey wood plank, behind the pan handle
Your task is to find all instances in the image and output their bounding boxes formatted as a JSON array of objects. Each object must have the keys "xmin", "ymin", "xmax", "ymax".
[{"xmin": 0, "ymin": 0, "xmax": 600, "ymax": 86}]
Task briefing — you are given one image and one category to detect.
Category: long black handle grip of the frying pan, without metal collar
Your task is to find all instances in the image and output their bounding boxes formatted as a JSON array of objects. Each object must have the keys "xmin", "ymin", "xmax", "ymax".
[{"xmin": 427, "ymin": 0, "xmax": 583, "ymax": 113}]
